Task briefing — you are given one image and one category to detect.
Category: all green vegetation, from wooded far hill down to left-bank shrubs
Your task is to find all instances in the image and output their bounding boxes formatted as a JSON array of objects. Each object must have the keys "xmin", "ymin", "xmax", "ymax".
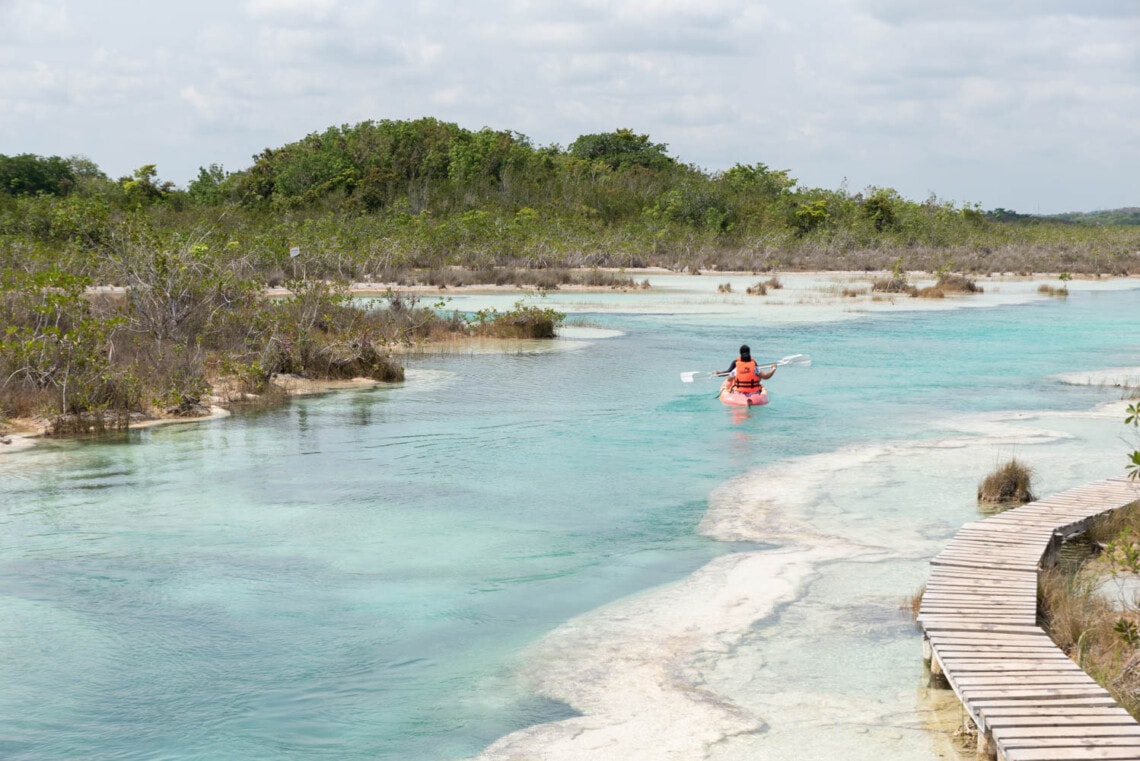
[{"xmin": 0, "ymin": 118, "xmax": 1140, "ymax": 432}]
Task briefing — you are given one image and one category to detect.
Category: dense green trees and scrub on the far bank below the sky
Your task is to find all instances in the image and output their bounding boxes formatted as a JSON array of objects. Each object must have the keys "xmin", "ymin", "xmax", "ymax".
[{"xmin": 0, "ymin": 118, "xmax": 1140, "ymax": 283}]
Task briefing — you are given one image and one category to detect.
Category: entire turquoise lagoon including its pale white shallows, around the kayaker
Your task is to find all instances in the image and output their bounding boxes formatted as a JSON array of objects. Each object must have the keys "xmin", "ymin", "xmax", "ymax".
[{"xmin": 0, "ymin": 276, "xmax": 1140, "ymax": 759}]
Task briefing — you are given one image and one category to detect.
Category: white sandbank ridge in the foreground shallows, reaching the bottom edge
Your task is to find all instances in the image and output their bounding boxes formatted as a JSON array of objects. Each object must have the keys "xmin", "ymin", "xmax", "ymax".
[{"xmin": 479, "ymin": 546, "xmax": 847, "ymax": 761}]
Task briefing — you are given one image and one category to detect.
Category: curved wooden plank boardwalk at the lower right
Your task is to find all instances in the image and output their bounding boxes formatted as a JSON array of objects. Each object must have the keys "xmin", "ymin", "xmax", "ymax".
[{"xmin": 918, "ymin": 478, "xmax": 1140, "ymax": 761}]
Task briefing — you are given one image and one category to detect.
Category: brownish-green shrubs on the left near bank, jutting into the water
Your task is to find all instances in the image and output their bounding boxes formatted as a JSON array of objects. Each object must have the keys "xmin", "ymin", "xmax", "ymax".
[{"xmin": 0, "ymin": 254, "xmax": 563, "ymax": 435}]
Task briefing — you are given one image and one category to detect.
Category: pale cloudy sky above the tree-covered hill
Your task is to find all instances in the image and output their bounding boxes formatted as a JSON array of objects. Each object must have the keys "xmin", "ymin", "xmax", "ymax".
[{"xmin": 0, "ymin": 0, "xmax": 1140, "ymax": 214}]
